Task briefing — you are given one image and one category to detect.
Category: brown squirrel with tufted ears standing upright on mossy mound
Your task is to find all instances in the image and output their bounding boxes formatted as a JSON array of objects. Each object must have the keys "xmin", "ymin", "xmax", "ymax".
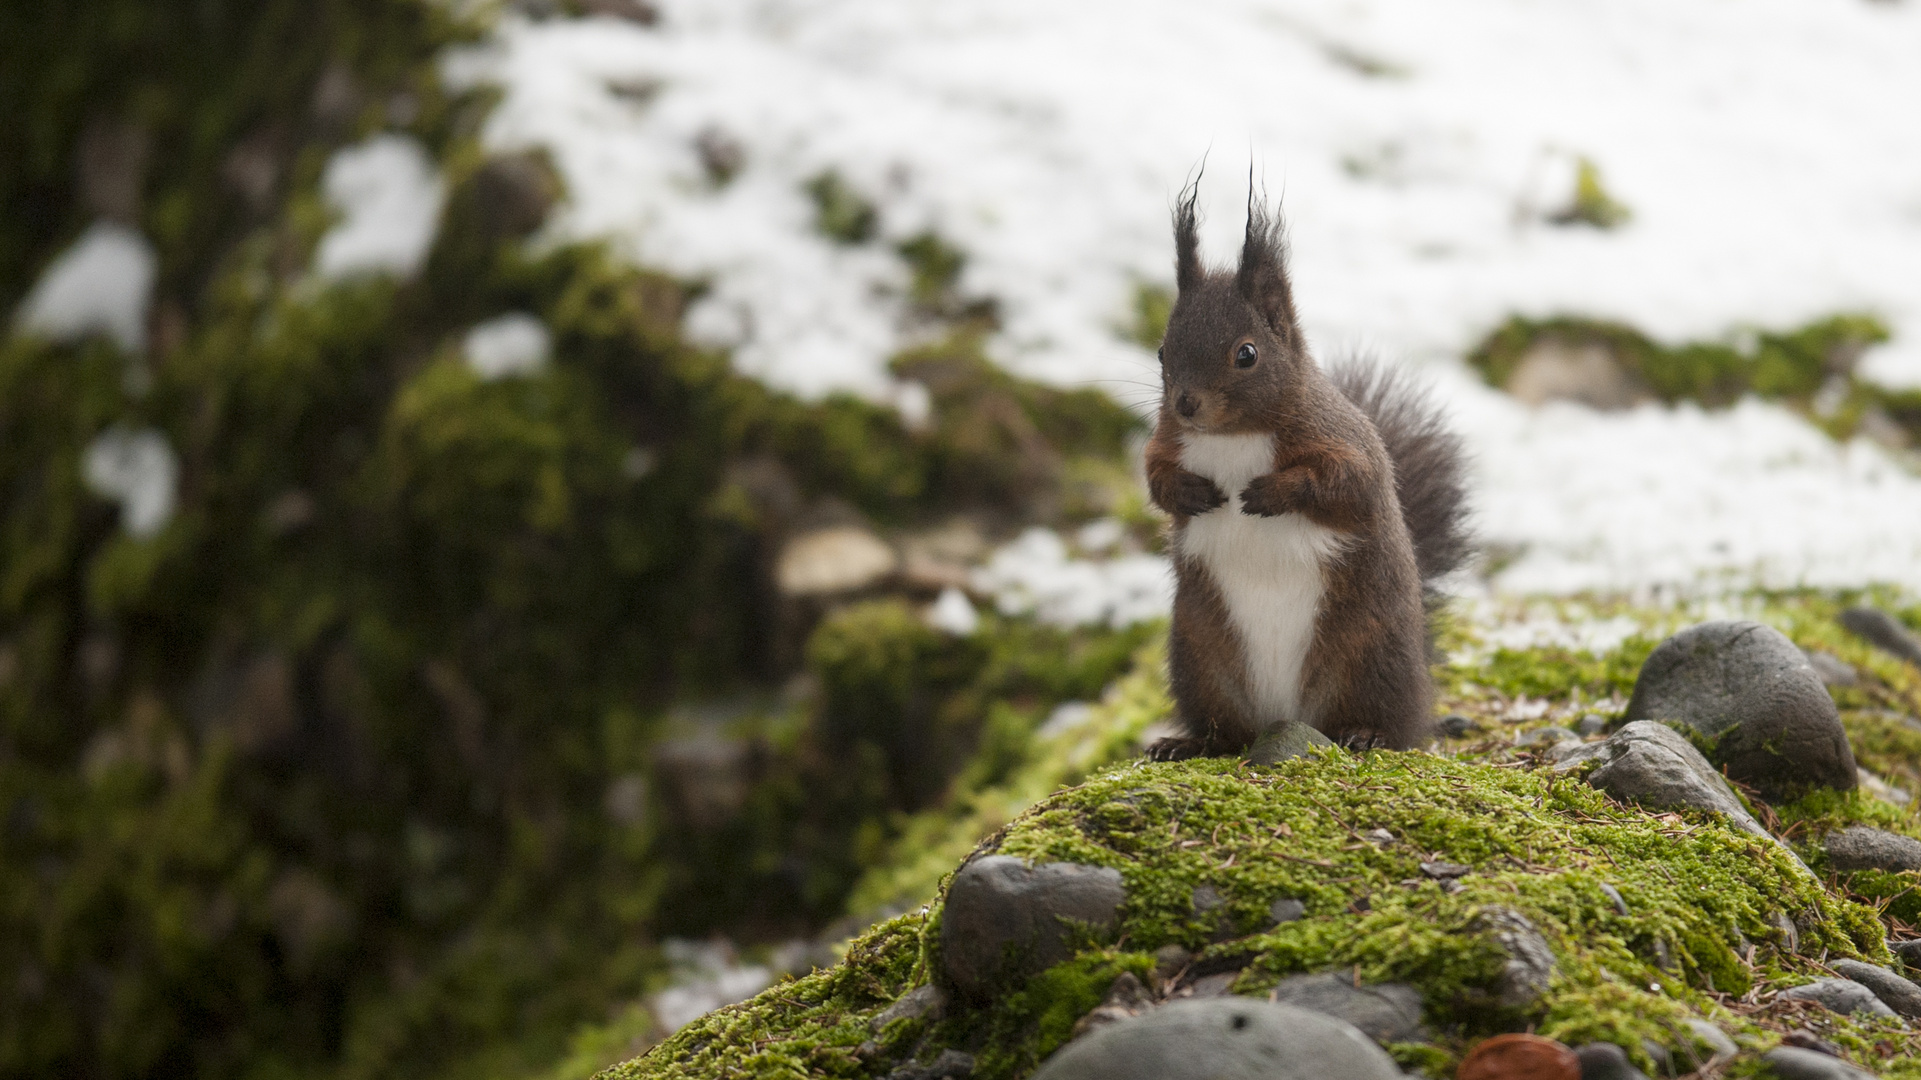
[{"xmin": 1147, "ymin": 179, "xmax": 1470, "ymax": 761}]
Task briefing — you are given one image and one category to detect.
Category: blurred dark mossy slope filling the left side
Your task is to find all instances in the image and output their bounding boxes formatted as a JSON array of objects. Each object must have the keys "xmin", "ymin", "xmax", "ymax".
[{"xmin": 0, "ymin": 0, "xmax": 1137, "ymax": 1078}]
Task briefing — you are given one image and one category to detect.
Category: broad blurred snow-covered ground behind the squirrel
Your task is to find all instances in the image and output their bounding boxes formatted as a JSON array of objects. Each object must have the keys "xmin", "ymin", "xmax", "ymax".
[{"xmin": 448, "ymin": 0, "xmax": 1921, "ymax": 591}]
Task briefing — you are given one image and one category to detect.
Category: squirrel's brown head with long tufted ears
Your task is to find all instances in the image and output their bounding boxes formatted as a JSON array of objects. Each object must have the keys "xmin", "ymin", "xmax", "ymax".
[{"xmin": 1160, "ymin": 181, "xmax": 1312, "ymax": 434}]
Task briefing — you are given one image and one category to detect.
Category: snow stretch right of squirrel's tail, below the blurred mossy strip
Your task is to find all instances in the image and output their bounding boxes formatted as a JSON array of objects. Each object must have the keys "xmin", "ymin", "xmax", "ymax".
[{"xmin": 1445, "ymin": 368, "xmax": 1921, "ymax": 596}]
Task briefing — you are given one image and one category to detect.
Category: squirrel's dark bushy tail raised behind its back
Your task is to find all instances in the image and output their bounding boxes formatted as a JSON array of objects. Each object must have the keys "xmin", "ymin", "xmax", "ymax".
[{"xmin": 1329, "ymin": 361, "xmax": 1473, "ymax": 588}]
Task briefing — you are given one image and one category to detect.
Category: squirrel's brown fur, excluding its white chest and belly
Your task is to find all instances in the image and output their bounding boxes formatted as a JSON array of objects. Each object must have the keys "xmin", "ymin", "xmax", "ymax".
[{"xmin": 1147, "ymin": 190, "xmax": 1466, "ymax": 759}]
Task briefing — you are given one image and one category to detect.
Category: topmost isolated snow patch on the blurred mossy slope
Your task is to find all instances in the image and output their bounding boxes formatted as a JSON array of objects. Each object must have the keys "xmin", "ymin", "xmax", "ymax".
[{"xmin": 313, "ymin": 135, "xmax": 446, "ymax": 279}]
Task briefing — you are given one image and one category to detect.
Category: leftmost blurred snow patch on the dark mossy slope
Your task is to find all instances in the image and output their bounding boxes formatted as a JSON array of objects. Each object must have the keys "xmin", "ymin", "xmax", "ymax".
[{"xmin": 17, "ymin": 221, "xmax": 158, "ymax": 354}]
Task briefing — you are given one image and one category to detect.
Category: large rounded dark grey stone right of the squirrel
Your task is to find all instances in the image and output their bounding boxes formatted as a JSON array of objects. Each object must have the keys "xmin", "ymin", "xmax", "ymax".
[{"xmin": 1625, "ymin": 623, "xmax": 1856, "ymax": 801}]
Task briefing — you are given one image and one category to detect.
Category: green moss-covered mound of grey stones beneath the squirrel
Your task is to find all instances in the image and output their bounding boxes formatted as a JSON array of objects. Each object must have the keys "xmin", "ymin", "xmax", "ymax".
[{"xmin": 626, "ymin": 623, "xmax": 1921, "ymax": 1080}]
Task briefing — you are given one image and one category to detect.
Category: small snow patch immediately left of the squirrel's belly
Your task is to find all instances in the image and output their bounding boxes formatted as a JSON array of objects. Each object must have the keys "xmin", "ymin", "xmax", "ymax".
[{"xmin": 974, "ymin": 528, "xmax": 1174, "ymax": 626}]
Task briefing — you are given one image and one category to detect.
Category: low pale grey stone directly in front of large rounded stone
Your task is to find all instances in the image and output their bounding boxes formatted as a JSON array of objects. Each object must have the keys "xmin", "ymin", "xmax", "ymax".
[{"xmin": 1554, "ymin": 721, "xmax": 1767, "ymax": 836}]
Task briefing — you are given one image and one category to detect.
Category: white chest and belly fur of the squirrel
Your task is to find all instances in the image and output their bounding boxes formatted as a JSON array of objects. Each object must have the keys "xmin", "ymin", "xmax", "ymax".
[{"xmin": 1176, "ymin": 434, "xmax": 1345, "ymax": 730}]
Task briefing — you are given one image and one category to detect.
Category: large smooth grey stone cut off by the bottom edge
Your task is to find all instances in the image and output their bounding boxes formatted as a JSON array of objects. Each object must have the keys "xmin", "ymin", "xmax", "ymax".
[{"xmin": 1033, "ymin": 997, "xmax": 1400, "ymax": 1080}]
